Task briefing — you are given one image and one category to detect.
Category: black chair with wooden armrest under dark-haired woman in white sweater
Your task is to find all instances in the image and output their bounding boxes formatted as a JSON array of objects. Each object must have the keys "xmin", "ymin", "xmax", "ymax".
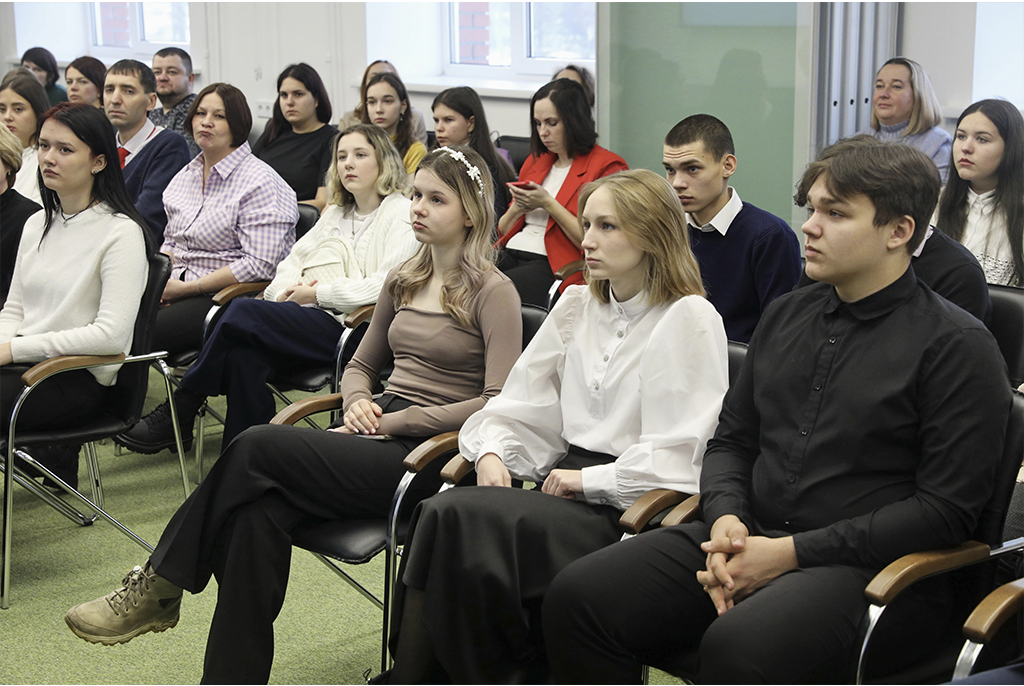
[{"xmin": 0, "ymin": 253, "xmax": 190, "ymax": 609}]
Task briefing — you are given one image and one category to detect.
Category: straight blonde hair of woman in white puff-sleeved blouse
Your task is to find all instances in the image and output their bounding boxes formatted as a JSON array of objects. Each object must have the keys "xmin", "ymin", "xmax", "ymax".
[{"xmin": 578, "ymin": 169, "xmax": 705, "ymax": 305}]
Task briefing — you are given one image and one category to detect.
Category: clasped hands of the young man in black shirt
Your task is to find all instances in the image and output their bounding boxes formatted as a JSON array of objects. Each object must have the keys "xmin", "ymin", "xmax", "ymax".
[{"xmin": 697, "ymin": 515, "xmax": 798, "ymax": 615}]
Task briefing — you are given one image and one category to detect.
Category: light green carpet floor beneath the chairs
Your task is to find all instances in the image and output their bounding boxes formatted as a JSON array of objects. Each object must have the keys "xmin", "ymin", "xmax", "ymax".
[{"xmin": 0, "ymin": 375, "xmax": 681, "ymax": 684}]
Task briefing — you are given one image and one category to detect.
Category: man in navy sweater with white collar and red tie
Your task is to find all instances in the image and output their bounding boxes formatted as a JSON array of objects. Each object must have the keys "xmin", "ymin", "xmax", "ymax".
[{"xmin": 103, "ymin": 59, "xmax": 190, "ymax": 245}]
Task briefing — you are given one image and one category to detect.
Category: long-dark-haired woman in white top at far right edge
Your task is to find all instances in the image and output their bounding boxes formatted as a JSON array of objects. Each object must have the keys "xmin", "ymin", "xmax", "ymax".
[{"xmin": 935, "ymin": 99, "xmax": 1024, "ymax": 288}]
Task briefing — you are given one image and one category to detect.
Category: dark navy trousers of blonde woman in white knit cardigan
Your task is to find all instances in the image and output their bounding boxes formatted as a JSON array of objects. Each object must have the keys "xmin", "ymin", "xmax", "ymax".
[{"xmin": 181, "ymin": 298, "xmax": 344, "ymax": 445}]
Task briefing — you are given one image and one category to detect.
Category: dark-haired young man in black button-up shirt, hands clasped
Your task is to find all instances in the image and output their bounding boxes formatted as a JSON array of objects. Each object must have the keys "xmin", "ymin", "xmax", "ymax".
[{"xmin": 544, "ymin": 138, "xmax": 1011, "ymax": 683}]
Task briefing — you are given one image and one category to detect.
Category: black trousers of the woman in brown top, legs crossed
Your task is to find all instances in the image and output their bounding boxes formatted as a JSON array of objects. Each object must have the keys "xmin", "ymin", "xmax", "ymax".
[{"xmin": 151, "ymin": 399, "xmax": 428, "ymax": 684}]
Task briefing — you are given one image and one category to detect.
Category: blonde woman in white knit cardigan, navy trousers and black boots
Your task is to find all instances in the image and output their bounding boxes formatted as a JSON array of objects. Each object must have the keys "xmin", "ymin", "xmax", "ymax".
[{"xmin": 118, "ymin": 124, "xmax": 419, "ymax": 454}]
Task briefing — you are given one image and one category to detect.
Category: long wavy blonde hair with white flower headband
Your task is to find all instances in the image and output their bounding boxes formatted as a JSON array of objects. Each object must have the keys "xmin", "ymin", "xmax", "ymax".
[{"xmin": 390, "ymin": 145, "xmax": 495, "ymax": 327}]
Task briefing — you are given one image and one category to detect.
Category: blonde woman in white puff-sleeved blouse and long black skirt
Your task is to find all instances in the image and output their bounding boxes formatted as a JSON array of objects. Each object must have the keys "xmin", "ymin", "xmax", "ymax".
[{"xmin": 382, "ymin": 170, "xmax": 728, "ymax": 683}]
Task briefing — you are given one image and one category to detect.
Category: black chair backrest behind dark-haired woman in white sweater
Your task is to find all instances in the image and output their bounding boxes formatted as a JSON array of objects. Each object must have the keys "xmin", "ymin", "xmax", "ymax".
[{"xmin": 110, "ymin": 253, "xmax": 171, "ymax": 424}]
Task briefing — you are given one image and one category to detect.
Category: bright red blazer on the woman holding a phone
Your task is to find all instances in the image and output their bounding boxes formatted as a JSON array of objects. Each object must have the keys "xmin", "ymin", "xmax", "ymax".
[{"xmin": 498, "ymin": 145, "xmax": 629, "ymax": 289}]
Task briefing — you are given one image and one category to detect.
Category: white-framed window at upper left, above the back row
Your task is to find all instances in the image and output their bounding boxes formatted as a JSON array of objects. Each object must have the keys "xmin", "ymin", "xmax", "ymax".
[{"xmin": 89, "ymin": 2, "xmax": 190, "ymax": 57}]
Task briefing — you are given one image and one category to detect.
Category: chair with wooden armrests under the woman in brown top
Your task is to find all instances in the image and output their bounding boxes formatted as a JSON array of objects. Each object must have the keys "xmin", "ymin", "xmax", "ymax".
[{"xmin": 270, "ymin": 304, "xmax": 547, "ymax": 672}]
